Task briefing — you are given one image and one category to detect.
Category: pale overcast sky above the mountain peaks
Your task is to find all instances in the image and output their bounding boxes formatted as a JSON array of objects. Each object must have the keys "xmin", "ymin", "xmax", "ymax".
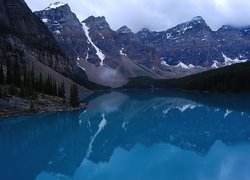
[{"xmin": 25, "ymin": 0, "xmax": 250, "ymax": 32}]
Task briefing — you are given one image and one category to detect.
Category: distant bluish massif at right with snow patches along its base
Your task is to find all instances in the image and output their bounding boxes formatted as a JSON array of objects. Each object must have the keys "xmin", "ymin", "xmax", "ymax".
[{"xmin": 137, "ymin": 16, "xmax": 250, "ymax": 68}]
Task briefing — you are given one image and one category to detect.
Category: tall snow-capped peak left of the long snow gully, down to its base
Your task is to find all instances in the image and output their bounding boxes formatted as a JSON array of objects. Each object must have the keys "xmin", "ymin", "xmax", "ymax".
[{"xmin": 34, "ymin": 2, "xmax": 105, "ymax": 89}]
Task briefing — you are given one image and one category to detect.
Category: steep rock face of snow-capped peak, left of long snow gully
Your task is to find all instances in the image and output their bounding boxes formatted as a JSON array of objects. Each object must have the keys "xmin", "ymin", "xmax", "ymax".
[{"xmin": 34, "ymin": 4, "xmax": 93, "ymax": 65}]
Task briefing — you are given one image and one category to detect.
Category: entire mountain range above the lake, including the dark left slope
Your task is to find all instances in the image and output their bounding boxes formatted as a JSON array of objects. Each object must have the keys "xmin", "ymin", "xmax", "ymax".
[{"xmin": 0, "ymin": 0, "xmax": 250, "ymax": 89}]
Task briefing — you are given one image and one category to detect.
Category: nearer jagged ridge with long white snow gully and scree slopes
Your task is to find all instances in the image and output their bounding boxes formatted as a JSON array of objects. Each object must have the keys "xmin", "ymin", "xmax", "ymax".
[{"xmin": 34, "ymin": 2, "xmax": 209, "ymax": 87}]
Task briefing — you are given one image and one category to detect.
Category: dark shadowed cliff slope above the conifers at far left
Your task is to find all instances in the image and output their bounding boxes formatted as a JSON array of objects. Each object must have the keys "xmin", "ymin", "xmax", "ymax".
[{"xmin": 0, "ymin": 0, "xmax": 71, "ymax": 76}]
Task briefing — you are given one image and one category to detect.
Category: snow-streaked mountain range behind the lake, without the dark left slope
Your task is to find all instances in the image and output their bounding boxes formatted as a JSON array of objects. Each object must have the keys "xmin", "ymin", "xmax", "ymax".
[{"xmin": 34, "ymin": 2, "xmax": 250, "ymax": 88}]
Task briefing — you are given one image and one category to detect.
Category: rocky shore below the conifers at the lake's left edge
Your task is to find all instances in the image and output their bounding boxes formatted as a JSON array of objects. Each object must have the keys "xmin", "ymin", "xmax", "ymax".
[{"xmin": 0, "ymin": 94, "xmax": 86, "ymax": 117}]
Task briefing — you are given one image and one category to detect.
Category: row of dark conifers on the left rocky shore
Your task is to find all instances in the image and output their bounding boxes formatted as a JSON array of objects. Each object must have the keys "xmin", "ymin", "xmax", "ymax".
[{"xmin": 0, "ymin": 58, "xmax": 79, "ymax": 106}]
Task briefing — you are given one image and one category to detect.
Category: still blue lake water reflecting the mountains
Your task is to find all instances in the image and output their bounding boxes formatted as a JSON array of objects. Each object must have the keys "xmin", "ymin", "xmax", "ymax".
[{"xmin": 0, "ymin": 90, "xmax": 250, "ymax": 180}]
